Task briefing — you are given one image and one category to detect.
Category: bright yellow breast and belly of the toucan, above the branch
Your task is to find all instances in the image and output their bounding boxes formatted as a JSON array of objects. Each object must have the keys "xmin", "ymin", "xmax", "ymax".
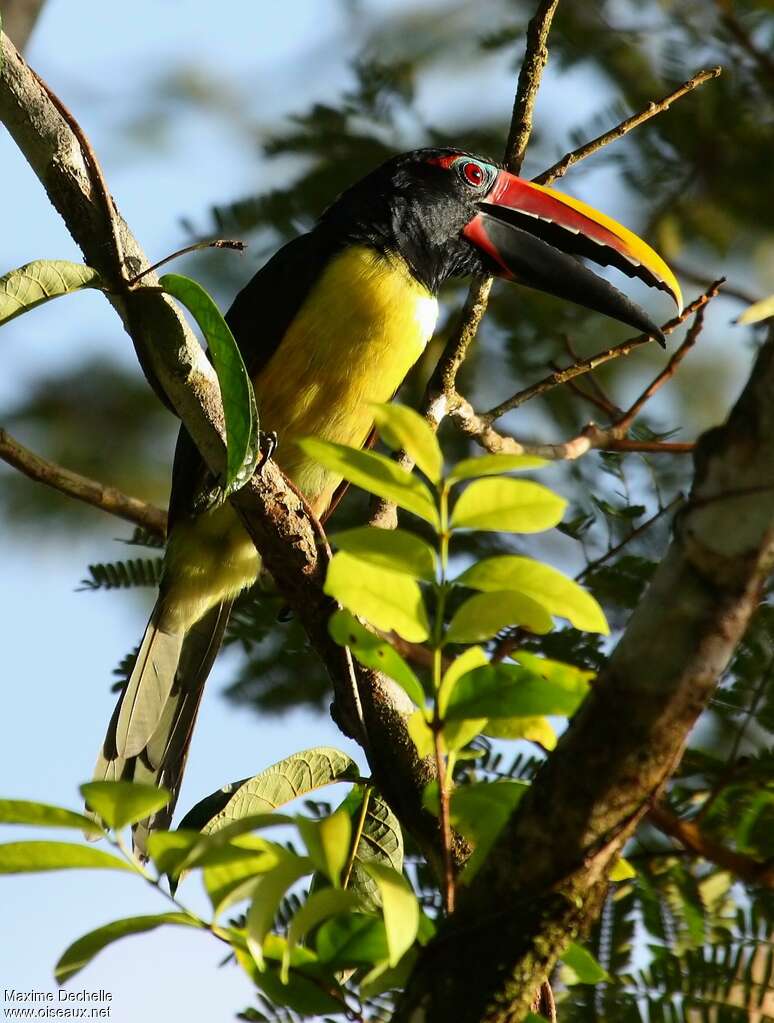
[{"xmin": 254, "ymin": 246, "xmax": 438, "ymax": 515}]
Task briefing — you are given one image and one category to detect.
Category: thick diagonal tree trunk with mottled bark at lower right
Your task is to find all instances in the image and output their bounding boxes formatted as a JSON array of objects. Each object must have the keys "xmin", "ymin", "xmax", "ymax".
[{"xmin": 395, "ymin": 336, "xmax": 774, "ymax": 1023}]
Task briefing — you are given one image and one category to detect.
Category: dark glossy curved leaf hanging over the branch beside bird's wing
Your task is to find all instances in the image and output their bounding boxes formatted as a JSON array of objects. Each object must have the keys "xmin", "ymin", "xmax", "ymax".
[{"xmin": 158, "ymin": 273, "xmax": 260, "ymax": 494}]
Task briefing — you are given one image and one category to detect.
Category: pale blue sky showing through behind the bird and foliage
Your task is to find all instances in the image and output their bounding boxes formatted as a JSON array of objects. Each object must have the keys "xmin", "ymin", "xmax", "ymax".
[{"xmin": 0, "ymin": 0, "xmax": 752, "ymax": 1023}]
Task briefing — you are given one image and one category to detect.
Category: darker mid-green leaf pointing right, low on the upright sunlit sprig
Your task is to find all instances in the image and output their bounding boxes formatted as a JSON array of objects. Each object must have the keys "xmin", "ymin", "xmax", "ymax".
[{"xmin": 446, "ymin": 664, "xmax": 588, "ymax": 720}]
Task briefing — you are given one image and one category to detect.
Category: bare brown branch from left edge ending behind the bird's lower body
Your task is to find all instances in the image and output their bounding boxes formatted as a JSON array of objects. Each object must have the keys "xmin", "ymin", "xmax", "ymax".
[{"xmin": 0, "ymin": 427, "xmax": 167, "ymax": 537}]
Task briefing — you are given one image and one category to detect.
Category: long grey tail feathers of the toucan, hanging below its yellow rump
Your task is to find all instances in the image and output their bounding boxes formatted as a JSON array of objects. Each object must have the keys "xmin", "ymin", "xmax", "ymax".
[{"xmin": 95, "ymin": 601, "xmax": 233, "ymax": 854}]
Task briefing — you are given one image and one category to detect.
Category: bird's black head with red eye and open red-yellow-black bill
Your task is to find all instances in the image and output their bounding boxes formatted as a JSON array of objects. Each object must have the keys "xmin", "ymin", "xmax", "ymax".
[{"xmin": 320, "ymin": 148, "xmax": 682, "ymax": 341}]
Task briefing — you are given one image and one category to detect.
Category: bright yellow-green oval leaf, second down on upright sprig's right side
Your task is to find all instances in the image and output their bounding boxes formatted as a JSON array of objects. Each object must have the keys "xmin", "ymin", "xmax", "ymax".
[{"xmin": 451, "ymin": 477, "xmax": 567, "ymax": 533}]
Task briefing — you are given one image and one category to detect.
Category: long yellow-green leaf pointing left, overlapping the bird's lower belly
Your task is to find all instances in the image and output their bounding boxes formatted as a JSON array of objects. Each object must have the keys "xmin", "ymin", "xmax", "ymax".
[{"xmin": 295, "ymin": 437, "xmax": 439, "ymax": 528}]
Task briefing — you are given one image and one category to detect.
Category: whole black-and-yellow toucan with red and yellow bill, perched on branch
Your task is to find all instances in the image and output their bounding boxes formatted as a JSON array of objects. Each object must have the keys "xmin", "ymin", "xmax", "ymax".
[{"xmin": 96, "ymin": 148, "xmax": 682, "ymax": 849}]
